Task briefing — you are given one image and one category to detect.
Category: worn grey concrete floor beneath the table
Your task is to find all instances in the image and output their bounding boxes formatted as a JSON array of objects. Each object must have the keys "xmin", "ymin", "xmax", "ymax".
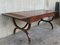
[{"xmin": 0, "ymin": 23, "xmax": 60, "ymax": 45}]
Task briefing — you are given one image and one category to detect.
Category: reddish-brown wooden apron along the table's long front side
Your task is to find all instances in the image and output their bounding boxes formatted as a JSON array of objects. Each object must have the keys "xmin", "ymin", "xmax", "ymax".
[{"xmin": 30, "ymin": 13, "xmax": 55, "ymax": 22}]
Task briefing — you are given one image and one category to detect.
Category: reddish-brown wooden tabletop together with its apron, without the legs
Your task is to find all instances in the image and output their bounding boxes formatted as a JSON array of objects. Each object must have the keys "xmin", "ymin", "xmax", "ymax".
[{"xmin": 2, "ymin": 10, "xmax": 55, "ymax": 22}]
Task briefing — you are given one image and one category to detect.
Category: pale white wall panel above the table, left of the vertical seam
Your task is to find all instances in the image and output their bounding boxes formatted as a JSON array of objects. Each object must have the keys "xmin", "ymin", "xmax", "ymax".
[{"xmin": 0, "ymin": 0, "xmax": 44, "ymax": 13}]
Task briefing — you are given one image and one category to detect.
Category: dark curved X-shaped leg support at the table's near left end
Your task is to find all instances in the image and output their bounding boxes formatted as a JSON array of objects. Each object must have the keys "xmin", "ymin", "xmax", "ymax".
[{"xmin": 13, "ymin": 18, "xmax": 31, "ymax": 43}]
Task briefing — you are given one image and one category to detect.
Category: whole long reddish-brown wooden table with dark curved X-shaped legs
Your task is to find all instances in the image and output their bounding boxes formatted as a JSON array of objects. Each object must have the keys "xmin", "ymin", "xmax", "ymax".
[{"xmin": 2, "ymin": 10, "xmax": 55, "ymax": 43}]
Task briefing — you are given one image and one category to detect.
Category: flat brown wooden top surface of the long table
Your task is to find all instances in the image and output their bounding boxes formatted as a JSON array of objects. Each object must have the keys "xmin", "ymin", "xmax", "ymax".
[{"xmin": 2, "ymin": 10, "xmax": 55, "ymax": 19}]
